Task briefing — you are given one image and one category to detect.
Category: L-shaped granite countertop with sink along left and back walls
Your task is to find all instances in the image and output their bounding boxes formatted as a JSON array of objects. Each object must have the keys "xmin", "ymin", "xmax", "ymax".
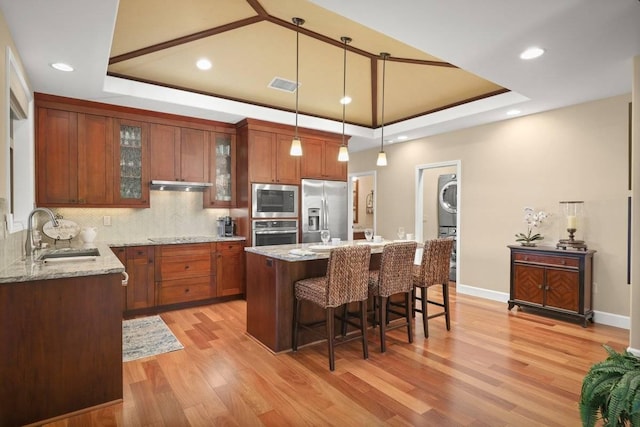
[{"xmin": 0, "ymin": 235, "xmax": 246, "ymax": 283}]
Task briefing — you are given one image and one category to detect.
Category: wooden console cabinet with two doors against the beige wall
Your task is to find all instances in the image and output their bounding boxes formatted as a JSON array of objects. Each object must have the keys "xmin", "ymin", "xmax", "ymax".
[{"xmin": 509, "ymin": 245, "xmax": 595, "ymax": 327}]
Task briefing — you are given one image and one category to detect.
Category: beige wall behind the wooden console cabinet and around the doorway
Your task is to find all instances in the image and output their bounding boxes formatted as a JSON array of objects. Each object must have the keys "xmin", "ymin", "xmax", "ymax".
[{"xmin": 349, "ymin": 95, "xmax": 630, "ymax": 316}]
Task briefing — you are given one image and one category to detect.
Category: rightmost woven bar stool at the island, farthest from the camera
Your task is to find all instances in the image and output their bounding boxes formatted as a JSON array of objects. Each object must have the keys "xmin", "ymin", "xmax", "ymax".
[{"xmin": 412, "ymin": 238, "xmax": 454, "ymax": 338}]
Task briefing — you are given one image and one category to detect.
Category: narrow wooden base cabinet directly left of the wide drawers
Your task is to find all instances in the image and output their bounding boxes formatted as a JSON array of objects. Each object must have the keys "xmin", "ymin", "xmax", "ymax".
[{"xmin": 124, "ymin": 246, "xmax": 156, "ymax": 313}]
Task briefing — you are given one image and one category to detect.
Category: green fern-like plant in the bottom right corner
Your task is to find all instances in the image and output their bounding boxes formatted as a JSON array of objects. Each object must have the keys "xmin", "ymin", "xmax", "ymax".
[{"xmin": 580, "ymin": 345, "xmax": 640, "ymax": 427}]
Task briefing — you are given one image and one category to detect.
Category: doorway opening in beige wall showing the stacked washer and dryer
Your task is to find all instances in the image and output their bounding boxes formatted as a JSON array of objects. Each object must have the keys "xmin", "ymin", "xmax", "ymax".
[{"xmin": 415, "ymin": 160, "xmax": 461, "ymax": 283}]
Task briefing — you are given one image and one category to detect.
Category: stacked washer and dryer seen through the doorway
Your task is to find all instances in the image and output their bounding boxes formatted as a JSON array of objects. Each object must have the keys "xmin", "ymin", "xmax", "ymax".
[{"xmin": 438, "ymin": 174, "xmax": 458, "ymax": 281}]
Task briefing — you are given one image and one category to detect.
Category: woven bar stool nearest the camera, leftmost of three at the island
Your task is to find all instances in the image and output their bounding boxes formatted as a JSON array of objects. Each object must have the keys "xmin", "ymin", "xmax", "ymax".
[{"xmin": 292, "ymin": 245, "xmax": 371, "ymax": 371}]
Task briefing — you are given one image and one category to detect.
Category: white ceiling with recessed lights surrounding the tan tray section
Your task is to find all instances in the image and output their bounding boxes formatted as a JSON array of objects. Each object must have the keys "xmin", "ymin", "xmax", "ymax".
[{"xmin": 0, "ymin": 0, "xmax": 640, "ymax": 151}]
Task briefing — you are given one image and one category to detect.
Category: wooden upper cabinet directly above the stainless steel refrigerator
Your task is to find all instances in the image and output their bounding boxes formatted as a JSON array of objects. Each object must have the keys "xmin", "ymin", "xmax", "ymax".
[{"xmin": 300, "ymin": 138, "xmax": 347, "ymax": 181}]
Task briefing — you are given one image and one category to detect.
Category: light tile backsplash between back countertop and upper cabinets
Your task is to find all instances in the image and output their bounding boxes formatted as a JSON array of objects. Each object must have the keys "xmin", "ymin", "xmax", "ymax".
[{"xmin": 50, "ymin": 191, "xmax": 229, "ymax": 243}]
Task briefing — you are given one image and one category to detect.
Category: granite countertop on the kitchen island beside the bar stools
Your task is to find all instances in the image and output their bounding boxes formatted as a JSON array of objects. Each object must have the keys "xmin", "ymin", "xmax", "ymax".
[{"xmin": 244, "ymin": 240, "xmax": 392, "ymax": 262}]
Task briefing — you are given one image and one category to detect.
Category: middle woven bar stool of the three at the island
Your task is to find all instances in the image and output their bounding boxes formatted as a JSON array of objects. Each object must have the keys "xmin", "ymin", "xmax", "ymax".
[{"xmin": 369, "ymin": 242, "xmax": 418, "ymax": 353}]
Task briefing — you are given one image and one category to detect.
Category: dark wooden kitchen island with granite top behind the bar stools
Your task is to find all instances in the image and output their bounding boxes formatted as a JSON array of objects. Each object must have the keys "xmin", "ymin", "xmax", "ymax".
[{"xmin": 245, "ymin": 241, "xmax": 383, "ymax": 353}]
